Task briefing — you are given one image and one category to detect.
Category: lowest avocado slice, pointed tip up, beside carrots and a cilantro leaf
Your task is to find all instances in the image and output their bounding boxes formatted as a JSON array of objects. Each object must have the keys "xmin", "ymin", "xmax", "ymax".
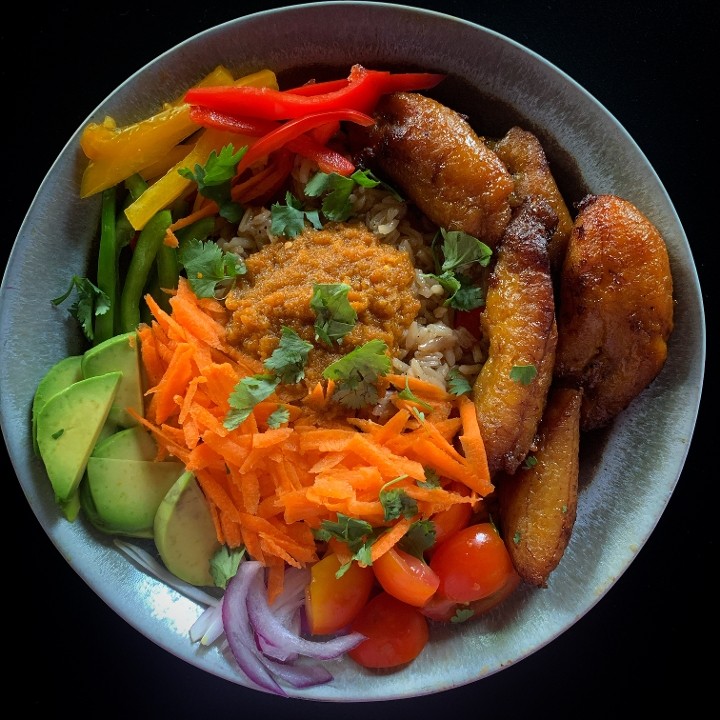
[{"xmin": 154, "ymin": 470, "xmax": 221, "ymax": 585}]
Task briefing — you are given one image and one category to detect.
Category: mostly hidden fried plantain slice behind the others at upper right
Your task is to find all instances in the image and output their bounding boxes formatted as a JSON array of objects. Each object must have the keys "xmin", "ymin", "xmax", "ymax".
[{"xmin": 487, "ymin": 126, "xmax": 573, "ymax": 272}]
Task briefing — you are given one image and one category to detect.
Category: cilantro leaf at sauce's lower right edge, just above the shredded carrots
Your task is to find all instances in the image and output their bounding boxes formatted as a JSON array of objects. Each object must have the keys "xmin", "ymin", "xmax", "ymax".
[{"xmin": 323, "ymin": 340, "xmax": 391, "ymax": 408}]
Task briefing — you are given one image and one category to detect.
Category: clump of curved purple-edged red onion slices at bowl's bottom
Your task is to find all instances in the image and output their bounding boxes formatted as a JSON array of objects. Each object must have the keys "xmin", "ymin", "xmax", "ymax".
[{"xmin": 222, "ymin": 560, "xmax": 365, "ymax": 696}]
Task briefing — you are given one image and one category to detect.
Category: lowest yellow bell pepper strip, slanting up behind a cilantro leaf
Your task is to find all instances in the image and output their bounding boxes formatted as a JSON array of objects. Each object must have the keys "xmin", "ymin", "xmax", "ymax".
[{"xmin": 125, "ymin": 130, "xmax": 242, "ymax": 230}]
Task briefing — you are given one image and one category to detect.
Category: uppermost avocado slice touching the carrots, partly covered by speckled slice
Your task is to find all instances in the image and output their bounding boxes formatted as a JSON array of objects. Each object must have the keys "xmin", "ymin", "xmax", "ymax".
[{"xmin": 82, "ymin": 331, "xmax": 144, "ymax": 428}]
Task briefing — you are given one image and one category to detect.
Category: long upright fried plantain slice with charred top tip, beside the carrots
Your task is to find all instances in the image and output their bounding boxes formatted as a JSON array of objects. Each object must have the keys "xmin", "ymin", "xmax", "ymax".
[{"xmin": 473, "ymin": 197, "xmax": 557, "ymax": 474}]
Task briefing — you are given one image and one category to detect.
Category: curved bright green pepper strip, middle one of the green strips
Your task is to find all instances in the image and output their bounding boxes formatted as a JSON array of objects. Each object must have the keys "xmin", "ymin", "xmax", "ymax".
[{"xmin": 120, "ymin": 210, "xmax": 172, "ymax": 332}]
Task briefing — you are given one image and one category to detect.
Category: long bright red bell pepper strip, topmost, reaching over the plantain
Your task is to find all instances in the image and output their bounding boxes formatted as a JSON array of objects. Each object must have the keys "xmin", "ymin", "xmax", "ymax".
[{"xmin": 184, "ymin": 65, "xmax": 445, "ymax": 120}]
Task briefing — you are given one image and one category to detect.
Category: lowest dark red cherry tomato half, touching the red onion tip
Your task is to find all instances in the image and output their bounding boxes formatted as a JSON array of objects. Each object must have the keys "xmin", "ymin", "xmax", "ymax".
[{"xmin": 348, "ymin": 592, "xmax": 430, "ymax": 668}]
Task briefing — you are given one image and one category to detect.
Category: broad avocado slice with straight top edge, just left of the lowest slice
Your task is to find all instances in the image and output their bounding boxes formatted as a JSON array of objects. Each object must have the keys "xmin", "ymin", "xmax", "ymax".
[{"xmin": 86, "ymin": 455, "xmax": 185, "ymax": 538}]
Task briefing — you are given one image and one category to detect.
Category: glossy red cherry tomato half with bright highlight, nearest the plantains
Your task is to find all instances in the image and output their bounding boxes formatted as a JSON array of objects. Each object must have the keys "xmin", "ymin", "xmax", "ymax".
[{"xmin": 430, "ymin": 523, "xmax": 515, "ymax": 603}]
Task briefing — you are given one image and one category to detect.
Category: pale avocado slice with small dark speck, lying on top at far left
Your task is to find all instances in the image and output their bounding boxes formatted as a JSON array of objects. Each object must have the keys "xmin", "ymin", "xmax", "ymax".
[{"xmin": 37, "ymin": 371, "xmax": 122, "ymax": 505}]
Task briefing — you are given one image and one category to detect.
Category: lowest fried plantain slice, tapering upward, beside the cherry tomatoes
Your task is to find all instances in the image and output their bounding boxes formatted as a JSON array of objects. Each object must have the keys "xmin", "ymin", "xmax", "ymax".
[{"xmin": 495, "ymin": 386, "xmax": 582, "ymax": 587}]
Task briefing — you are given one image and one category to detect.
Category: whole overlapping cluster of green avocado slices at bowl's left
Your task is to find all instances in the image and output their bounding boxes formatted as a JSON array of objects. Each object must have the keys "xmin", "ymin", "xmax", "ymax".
[{"xmin": 32, "ymin": 332, "xmax": 220, "ymax": 586}]
